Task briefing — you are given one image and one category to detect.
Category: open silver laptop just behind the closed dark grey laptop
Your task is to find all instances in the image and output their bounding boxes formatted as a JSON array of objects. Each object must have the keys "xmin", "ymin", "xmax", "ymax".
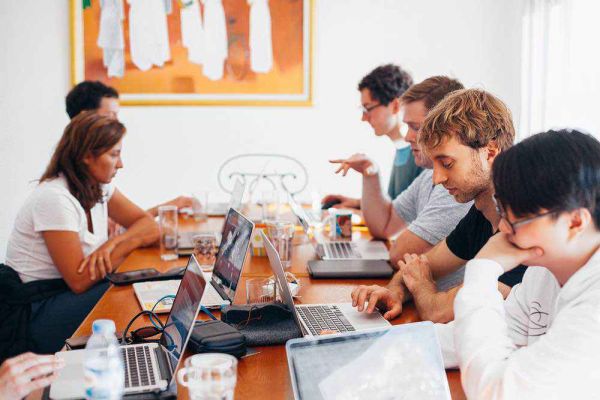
[{"xmin": 289, "ymin": 196, "xmax": 390, "ymax": 260}]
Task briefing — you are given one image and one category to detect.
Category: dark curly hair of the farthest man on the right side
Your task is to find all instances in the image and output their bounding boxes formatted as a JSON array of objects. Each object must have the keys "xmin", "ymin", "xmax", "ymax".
[{"xmin": 358, "ymin": 64, "xmax": 413, "ymax": 106}]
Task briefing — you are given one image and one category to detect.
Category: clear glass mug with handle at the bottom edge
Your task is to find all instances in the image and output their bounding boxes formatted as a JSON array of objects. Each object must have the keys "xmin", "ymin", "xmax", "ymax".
[{"xmin": 177, "ymin": 353, "xmax": 237, "ymax": 400}]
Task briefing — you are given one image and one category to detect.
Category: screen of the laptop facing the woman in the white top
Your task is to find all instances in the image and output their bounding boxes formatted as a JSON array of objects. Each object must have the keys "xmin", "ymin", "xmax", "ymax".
[{"xmin": 212, "ymin": 208, "xmax": 254, "ymax": 300}]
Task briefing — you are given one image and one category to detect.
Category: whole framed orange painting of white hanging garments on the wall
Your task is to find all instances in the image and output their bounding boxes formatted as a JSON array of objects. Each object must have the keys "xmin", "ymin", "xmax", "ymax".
[{"xmin": 70, "ymin": 0, "xmax": 315, "ymax": 106}]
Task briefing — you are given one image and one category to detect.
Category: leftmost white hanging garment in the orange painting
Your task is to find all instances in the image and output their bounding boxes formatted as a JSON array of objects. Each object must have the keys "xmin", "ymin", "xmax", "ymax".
[{"xmin": 97, "ymin": 0, "xmax": 125, "ymax": 78}]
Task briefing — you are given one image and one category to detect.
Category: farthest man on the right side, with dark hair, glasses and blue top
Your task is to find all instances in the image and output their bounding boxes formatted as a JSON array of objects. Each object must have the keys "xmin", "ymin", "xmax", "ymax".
[{"xmin": 322, "ymin": 64, "xmax": 423, "ymax": 209}]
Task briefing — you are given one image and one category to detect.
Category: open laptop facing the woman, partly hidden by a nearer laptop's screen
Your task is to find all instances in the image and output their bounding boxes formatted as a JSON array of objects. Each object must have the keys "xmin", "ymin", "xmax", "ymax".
[{"xmin": 133, "ymin": 208, "xmax": 254, "ymax": 313}]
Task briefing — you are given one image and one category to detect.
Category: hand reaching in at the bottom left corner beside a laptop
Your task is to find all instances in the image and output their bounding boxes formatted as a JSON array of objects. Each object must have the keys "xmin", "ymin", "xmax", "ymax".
[{"xmin": 0, "ymin": 353, "xmax": 65, "ymax": 399}]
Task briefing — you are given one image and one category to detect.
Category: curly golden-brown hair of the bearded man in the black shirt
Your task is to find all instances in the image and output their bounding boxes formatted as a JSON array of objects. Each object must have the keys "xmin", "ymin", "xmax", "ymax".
[{"xmin": 418, "ymin": 89, "xmax": 515, "ymax": 151}]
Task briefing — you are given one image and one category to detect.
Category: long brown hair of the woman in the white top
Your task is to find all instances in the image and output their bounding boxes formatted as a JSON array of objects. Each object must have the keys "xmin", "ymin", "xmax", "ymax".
[{"xmin": 40, "ymin": 111, "xmax": 125, "ymax": 210}]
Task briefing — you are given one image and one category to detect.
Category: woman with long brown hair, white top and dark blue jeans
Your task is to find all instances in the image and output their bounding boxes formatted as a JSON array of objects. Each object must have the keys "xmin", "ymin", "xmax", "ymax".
[{"xmin": 6, "ymin": 111, "xmax": 158, "ymax": 353}]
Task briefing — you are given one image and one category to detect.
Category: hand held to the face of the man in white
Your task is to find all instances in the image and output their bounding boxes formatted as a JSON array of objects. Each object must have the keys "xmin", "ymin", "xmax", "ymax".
[{"xmin": 475, "ymin": 232, "xmax": 544, "ymax": 272}]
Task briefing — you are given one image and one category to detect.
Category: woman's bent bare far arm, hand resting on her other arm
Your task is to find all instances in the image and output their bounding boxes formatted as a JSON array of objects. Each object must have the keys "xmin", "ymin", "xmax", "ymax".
[{"xmin": 77, "ymin": 189, "xmax": 159, "ymax": 281}]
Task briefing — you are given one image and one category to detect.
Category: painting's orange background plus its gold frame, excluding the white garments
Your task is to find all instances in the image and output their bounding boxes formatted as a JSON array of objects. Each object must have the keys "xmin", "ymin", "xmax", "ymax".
[{"xmin": 71, "ymin": 0, "xmax": 312, "ymax": 105}]
